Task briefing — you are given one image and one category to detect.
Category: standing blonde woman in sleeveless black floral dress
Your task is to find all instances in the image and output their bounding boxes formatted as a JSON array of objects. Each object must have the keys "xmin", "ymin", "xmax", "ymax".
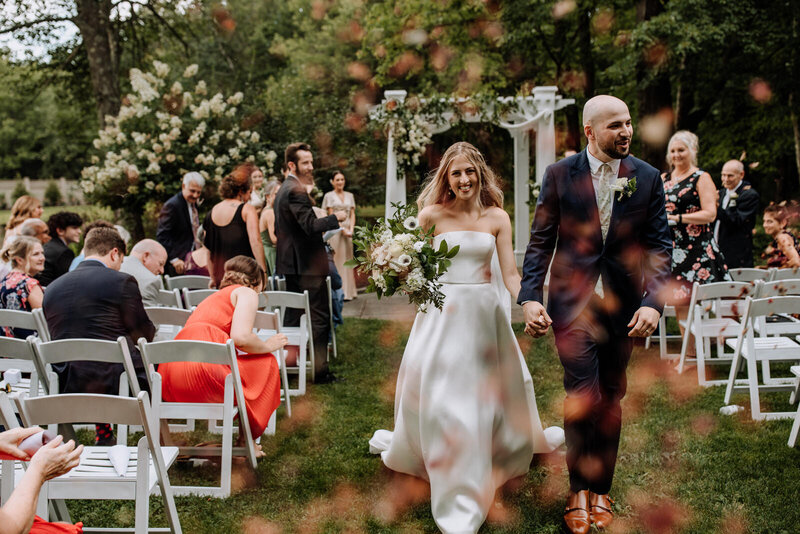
[{"xmin": 662, "ymin": 130, "xmax": 731, "ymax": 355}]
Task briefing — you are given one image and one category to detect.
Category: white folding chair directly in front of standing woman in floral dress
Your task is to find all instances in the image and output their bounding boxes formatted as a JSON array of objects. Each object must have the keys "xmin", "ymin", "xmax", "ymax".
[{"xmin": 678, "ymin": 282, "xmax": 755, "ymax": 387}]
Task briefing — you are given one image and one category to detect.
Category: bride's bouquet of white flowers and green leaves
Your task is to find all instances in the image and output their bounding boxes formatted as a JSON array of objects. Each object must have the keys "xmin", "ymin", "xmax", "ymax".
[{"xmin": 345, "ymin": 204, "xmax": 458, "ymax": 312}]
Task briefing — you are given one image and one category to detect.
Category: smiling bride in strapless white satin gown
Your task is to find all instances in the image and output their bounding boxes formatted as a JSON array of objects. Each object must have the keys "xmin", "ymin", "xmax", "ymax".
[{"xmin": 370, "ymin": 142, "xmax": 563, "ymax": 534}]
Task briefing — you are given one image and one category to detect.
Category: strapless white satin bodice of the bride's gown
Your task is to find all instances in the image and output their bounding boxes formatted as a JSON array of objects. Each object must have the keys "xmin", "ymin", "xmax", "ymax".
[{"xmin": 433, "ymin": 230, "xmax": 495, "ymax": 284}]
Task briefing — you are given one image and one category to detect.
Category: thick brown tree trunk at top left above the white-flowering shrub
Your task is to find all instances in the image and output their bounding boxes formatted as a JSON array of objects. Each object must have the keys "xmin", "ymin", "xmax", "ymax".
[{"xmin": 75, "ymin": 0, "xmax": 120, "ymax": 127}]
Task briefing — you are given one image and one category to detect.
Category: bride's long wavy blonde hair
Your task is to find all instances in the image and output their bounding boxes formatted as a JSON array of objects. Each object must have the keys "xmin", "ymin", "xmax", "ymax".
[{"xmin": 417, "ymin": 141, "xmax": 503, "ymax": 211}]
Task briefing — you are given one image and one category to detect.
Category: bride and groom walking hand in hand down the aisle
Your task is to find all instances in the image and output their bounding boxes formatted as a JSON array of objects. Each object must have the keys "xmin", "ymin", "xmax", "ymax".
[{"xmin": 370, "ymin": 95, "xmax": 672, "ymax": 534}]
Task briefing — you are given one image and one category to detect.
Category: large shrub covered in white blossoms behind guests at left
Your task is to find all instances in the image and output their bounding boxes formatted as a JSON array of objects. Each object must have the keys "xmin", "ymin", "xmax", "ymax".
[{"xmin": 80, "ymin": 61, "xmax": 277, "ymax": 234}]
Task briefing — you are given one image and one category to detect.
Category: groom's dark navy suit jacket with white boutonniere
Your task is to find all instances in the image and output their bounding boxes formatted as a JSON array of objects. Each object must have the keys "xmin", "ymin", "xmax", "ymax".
[{"xmin": 518, "ymin": 150, "xmax": 672, "ymax": 333}]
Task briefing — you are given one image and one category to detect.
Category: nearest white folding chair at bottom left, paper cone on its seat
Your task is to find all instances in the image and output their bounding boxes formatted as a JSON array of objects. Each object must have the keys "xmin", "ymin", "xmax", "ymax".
[{"xmin": 10, "ymin": 391, "xmax": 182, "ymax": 534}]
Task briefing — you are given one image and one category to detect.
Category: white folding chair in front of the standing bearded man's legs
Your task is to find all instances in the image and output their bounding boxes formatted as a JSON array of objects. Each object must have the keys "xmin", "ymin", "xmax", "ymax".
[{"xmin": 264, "ymin": 291, "xmax": 314, "ymax": 395}]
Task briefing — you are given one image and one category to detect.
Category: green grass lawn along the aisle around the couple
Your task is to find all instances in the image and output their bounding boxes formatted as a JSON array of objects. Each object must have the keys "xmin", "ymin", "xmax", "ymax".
[{"xmin": 70, "ymin": 319, "xmax": 800, "ymax": 534}]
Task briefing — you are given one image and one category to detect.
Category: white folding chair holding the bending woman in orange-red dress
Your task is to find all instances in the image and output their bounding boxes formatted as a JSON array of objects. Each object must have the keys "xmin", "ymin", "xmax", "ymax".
[{"xmin": 139, "ymin": 338, "xmax": 256, "ymax": 498}]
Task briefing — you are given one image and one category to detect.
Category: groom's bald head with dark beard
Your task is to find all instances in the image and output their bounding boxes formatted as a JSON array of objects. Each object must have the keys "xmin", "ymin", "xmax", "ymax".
[{"xmin": 583, "ymin": 95, "xmax": 633, "ymax": 162}]
